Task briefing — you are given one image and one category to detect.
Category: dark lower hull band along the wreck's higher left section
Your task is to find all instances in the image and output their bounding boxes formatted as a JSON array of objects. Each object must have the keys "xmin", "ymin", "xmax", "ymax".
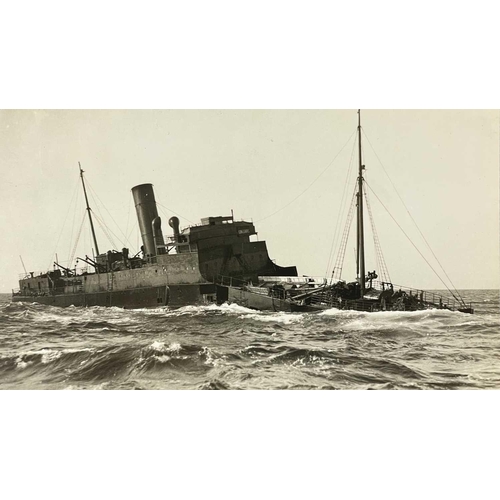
[{"xmin": 12, "ymin": 284, "xmax": 215, "ymax": 309}]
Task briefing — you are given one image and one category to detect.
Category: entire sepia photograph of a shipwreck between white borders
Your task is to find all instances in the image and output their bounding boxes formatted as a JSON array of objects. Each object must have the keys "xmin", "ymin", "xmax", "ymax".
[{"xmin": 0, "ymin": 109, "xmax": 500, "ymax": 389}]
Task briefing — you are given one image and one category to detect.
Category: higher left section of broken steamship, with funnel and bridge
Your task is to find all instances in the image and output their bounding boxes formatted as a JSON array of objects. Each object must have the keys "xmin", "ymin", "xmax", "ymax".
[{"xmin": 12, "ymin": 167, "xmax": 297, "ymax": 308}]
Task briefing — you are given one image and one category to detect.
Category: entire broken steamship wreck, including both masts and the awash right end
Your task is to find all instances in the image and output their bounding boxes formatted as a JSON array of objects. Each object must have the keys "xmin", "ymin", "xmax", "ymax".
[{"xmin": 12, "ymin": 110, "xmax": 474, "ymax": 313}]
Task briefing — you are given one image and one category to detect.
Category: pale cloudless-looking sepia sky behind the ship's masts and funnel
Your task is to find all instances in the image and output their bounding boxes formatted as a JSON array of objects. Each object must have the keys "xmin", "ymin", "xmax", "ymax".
[{"xmin": 0, "ymin": 110, "xmax": 500, "ymax": 292}]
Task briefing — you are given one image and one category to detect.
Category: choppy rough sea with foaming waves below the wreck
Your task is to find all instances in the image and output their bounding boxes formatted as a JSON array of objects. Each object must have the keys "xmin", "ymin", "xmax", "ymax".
[{"xmin": 0, "ymin": 290, "xmax": 500, "ymax": 389}]
